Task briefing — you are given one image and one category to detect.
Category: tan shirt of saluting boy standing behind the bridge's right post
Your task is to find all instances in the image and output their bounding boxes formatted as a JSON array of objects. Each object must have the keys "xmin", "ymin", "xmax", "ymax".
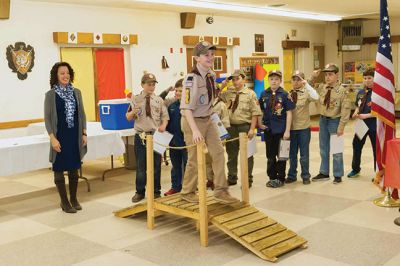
[{"xmin": 220, "ymin": 86, "xmax": 262, "ymax": 125}]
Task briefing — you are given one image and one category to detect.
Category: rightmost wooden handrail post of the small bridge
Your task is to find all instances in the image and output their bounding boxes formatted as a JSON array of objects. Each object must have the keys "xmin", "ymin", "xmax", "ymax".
[{"xmin": 239, "ymin": 132, "xmax": 250, "ymax": 203}]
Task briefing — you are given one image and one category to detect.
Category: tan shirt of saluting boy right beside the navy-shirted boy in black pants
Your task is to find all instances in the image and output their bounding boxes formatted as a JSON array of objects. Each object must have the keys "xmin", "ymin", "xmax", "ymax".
[{"xmin": 289, "ymin": 83, "xmax": 319, "ymax": 130}]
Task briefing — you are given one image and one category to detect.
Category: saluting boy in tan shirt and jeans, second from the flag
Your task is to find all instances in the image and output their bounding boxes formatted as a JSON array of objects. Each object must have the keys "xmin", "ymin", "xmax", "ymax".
[{"xmin": 312, "ymin": 64, "xmax": 351, "ymax": 184}]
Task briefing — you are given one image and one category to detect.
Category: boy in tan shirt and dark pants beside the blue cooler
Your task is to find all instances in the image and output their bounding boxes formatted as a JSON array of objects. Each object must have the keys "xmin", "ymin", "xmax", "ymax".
[{"xmin": 126, "ymin": 73, "xmax": 169, "ymax": 202}]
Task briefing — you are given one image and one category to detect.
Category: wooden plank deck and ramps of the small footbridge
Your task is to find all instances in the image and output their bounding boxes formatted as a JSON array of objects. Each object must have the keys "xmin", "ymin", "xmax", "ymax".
[{"xmin": 114, "ymin": 194, "xmax": 307, "ymax": 262}]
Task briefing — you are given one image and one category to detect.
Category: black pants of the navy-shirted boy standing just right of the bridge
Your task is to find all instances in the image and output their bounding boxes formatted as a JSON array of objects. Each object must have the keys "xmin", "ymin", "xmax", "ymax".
[{"xmin": 264, "ymin": 130, "xmax": 286, "ymax": 182}]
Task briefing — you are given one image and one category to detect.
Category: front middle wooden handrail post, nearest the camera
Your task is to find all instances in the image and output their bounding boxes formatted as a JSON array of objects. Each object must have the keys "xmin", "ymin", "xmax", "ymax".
[{"xmin": 196, "ymin": 141, "xmax": 208, "ymax": 247}]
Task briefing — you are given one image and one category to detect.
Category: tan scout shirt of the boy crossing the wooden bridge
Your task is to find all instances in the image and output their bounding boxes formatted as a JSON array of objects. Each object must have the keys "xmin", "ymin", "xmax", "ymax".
[{"xmin": 181, "ymin": 65, "xmax": 217, "ymax": 118}]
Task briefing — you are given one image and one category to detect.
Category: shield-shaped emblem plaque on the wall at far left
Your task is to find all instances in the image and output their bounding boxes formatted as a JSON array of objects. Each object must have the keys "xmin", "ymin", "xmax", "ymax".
[{"xmin": 6, "ymin": 42, "xmax": 35, "ymax": 80}]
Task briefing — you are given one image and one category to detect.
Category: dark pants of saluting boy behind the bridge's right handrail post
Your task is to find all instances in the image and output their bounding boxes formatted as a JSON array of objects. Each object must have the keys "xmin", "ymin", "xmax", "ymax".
[{"xmin": 226, "ymin": 123, "xmax": 255, "ymax": 183}]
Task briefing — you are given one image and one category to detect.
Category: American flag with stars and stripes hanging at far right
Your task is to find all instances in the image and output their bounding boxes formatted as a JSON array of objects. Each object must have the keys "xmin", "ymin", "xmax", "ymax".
[{"xmin": 371, "ymin": 0, "xmax": 396, "ymax": 195}]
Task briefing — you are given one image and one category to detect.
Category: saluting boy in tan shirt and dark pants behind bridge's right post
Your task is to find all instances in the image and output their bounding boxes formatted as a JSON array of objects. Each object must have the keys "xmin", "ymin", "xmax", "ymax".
[{"xmin": 221, "ymin": 70, "xmax": 262, "ymax": 187}]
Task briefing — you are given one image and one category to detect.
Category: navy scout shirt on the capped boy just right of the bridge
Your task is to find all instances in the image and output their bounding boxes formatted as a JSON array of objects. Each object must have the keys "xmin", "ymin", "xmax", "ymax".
[{"xmin": 259, "ymin": 87, "xmax": 295, "ymax": 134}]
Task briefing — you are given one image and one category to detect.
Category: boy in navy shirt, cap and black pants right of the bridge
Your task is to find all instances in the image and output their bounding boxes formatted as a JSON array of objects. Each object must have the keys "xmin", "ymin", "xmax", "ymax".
[{"xmin": 259, "ymin": 70, "xmax": 295, "ymax": 188}]
